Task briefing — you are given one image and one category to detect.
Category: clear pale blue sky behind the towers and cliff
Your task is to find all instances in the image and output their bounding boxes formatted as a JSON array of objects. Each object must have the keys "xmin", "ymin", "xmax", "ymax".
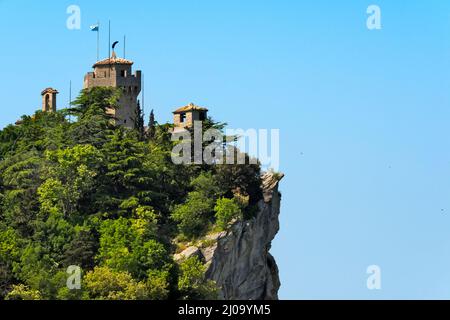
[{"xmin": 0, "ymin": 0, "xmax": 450, "ymax": 299}]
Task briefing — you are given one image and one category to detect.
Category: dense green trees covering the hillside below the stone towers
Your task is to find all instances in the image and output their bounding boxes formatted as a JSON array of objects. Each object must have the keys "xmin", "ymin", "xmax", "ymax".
[{"xmin": 0, "ymin": 88, "xmax": 261, "ymax": 299}]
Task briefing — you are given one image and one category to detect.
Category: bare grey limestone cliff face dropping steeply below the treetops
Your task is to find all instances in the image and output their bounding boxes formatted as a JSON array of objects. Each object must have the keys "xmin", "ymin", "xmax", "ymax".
[{"xmin": 200, "ymin": 173, "xmax": 283, "ymax": 300}]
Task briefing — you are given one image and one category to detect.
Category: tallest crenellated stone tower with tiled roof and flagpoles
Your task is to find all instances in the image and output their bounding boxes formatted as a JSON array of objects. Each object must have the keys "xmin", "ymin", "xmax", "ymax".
[{"xmin": 83, "ymin": 51, "xmax": 142, "ymax": 128}]
